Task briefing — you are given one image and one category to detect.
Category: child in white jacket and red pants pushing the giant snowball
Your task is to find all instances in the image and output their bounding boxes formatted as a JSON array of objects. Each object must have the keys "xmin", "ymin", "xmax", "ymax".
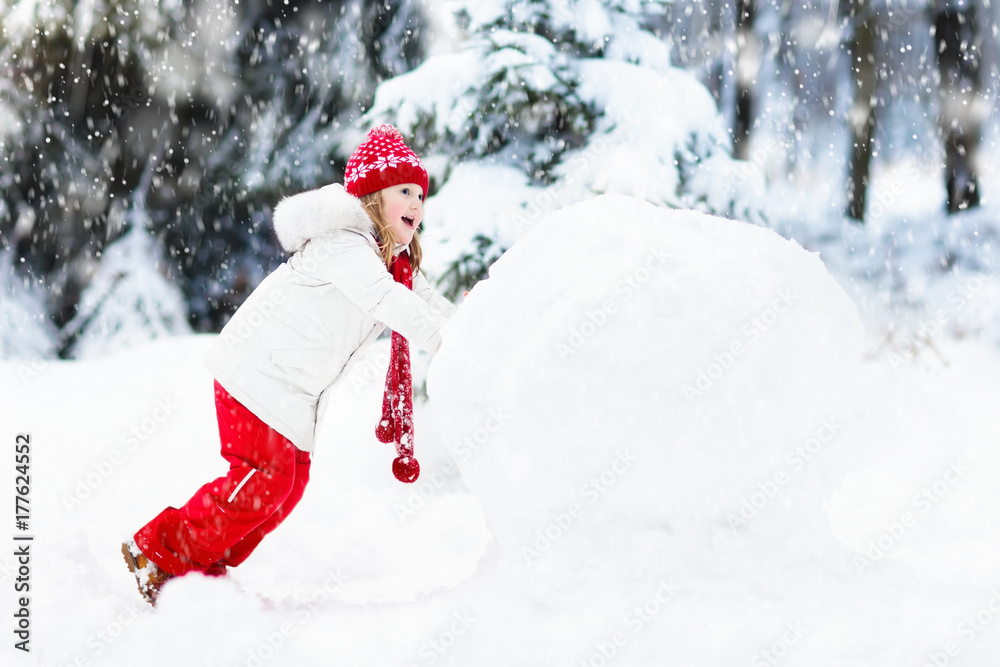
[{"xmin": 122, "ymin": 125, "xmax": 455, "ymax": 604}]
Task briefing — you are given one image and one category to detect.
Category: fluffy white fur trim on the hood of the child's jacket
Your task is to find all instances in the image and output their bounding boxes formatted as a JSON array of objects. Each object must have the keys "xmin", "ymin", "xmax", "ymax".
[{"xmin": 272, "ymin": 183, "xmax": 375, "ymax": 253}]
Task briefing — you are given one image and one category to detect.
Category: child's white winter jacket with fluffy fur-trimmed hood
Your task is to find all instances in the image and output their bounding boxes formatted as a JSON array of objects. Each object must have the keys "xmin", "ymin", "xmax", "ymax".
[{"xmin": 205, "ymin": 184, "xmax": 455, "ymax": 452}]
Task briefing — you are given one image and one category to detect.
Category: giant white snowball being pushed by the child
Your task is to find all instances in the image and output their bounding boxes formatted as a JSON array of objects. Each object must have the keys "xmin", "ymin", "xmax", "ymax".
[{"xmin": 428, "ymin": 195, "xmax": 862, "ymax": 562}]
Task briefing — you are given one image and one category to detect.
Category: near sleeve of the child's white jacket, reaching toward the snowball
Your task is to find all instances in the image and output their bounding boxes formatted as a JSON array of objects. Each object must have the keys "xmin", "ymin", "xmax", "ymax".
[{"xmin": 292, "ymin": 230, "xmax": 448, "ymax": 352}]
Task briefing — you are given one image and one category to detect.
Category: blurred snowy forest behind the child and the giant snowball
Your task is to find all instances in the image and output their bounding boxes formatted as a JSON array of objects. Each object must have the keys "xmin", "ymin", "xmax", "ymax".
[{"xmin": 0, "ymin": 0, "xmax": 1000, "ymax": 358}]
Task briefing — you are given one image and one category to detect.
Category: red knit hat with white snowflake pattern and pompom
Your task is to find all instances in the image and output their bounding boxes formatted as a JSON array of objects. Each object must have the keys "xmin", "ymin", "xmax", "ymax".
[{"xmin": 344, "ymin": 125, "xmax": 427, "ymax": 197}]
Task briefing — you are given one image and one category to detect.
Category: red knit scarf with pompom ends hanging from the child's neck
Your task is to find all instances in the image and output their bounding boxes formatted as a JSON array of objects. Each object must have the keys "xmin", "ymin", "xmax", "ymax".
[{"xmin": 375, "ymin": 250, "xmax": 420, "ymax": 484}]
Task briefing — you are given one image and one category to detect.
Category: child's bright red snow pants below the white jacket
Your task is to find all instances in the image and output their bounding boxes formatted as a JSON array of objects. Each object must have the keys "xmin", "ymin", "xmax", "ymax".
[{"xmin": 135, "ymin": 382, "xmax": 310, "ymax": 575}]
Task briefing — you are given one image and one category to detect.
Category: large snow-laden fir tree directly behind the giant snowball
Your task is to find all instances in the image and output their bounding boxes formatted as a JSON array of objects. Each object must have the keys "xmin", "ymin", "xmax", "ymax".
[{"xmin": 356, "ymin": 0, "xmax": 763, "ymax": 296}]
